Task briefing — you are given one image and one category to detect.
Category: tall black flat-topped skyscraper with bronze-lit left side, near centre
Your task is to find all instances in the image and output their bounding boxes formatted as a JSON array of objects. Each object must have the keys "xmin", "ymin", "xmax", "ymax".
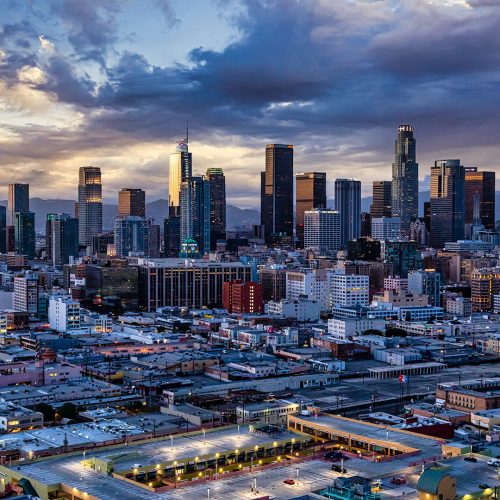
[{"xmin": 260, "ymin": 144, "xmax": 293, "ymax": 245}]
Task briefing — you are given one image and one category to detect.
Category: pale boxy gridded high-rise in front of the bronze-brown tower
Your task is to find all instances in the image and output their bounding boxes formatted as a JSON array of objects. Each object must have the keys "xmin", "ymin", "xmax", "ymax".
[{"xmin": 304, "ymin": 208, "xmax": 341, "ymax": 254}]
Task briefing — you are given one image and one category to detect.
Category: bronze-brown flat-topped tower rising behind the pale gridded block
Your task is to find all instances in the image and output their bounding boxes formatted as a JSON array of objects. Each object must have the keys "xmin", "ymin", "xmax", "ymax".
[{"xmin": 295, "ymin": 172, "xmax": 326, "ymax": 248}]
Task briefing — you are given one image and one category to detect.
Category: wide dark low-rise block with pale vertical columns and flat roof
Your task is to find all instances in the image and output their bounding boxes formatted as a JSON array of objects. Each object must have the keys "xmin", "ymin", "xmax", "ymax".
[{"xmin": 139, "ymin": 259, "xmax": 251, "ymax": 311}]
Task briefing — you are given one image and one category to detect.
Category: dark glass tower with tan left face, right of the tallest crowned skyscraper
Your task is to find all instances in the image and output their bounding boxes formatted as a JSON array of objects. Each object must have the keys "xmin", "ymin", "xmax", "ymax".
[{"xmin": 430, "ymin": 160, "xmax": 465, "ymax": 248}]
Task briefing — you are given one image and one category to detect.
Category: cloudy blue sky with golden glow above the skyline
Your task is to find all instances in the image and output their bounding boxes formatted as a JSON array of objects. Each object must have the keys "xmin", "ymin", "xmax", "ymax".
[{"xmin": 0, "ymin": 0, "xmax": 500, "ymax": 208}]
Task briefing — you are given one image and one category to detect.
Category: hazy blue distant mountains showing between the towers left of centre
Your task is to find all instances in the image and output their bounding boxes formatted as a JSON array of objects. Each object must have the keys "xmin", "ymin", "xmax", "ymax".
[{"xmin": 0, "ymin": 198, "xmax": 260, "ymax": 233}]
